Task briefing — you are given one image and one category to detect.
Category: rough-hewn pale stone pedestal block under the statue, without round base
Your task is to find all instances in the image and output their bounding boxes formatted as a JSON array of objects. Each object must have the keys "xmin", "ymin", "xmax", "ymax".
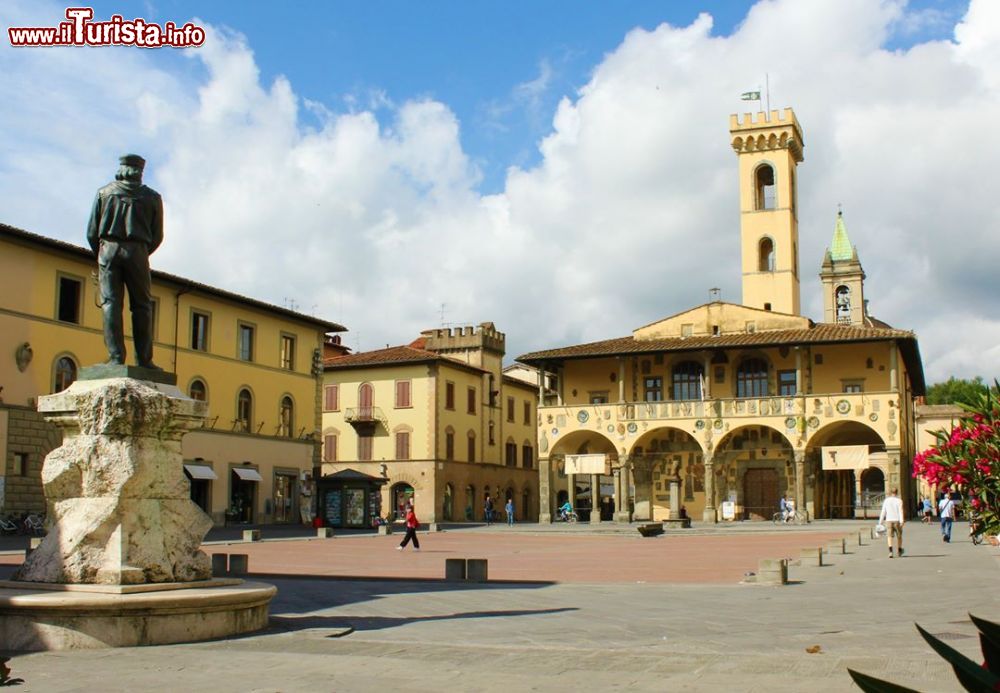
[{"xmin": 14, "ymin": 378, "xmax": 212, "ymax": 585}]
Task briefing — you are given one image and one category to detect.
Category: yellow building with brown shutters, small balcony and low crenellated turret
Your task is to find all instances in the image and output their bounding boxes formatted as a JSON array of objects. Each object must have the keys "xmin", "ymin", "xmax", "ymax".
[{"xmin": 319, "ymin": 323, "xmax": 538, "ymax": 526}]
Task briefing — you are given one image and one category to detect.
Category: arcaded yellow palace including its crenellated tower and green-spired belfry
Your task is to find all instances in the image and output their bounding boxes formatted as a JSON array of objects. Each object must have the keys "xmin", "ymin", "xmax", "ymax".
[{"xmin": 517, "ymin": 109, "xmax": 924, "ymax": 522}]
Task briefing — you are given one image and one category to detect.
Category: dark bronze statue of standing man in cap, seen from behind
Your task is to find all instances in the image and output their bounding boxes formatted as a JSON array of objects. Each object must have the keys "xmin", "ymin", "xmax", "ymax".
[{"xmin": 87, "ymin": 154, "xmax": 163, "ymax": 370}]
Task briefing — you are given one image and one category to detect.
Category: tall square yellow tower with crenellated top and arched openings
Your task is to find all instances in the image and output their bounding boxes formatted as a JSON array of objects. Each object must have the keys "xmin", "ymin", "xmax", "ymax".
[{"xmin": 729, "ymin": 108, "xmax": 805, "ymax": 315}]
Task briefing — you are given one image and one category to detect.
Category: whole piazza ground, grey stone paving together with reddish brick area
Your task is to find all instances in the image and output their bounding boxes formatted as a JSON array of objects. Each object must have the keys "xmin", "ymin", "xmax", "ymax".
[{"xmin": 0, "ymin": 522, "xmax": 1000, "ymax": 693}]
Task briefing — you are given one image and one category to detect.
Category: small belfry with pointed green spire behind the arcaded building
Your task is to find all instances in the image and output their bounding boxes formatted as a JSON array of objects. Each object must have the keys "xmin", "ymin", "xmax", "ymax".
[{"xmin": 819, "ymin": 212, "xmax": 868, "ymax": 325}]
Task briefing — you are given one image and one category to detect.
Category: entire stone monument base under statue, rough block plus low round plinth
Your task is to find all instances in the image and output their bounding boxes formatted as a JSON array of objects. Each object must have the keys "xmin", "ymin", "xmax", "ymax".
[{"xmin": 0, "ymin": 376, "xmax": 276, "ymax": 650}]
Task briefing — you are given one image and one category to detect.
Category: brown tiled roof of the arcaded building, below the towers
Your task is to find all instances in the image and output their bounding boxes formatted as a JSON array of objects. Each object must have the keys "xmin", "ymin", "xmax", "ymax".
[{"xmin": 517, "ymin": 323, "xmax": 916, "ymax": 365}]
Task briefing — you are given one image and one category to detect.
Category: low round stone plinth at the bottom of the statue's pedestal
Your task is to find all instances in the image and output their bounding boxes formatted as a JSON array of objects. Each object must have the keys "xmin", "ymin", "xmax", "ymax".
[{"xmin": 0, "ymin": 582, "xmax": 277, "ymax": 652}]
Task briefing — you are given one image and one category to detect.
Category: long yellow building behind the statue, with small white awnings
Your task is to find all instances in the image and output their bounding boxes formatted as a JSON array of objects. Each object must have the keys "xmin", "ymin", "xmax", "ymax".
[{"xmin": 0, "ymin": 225, "xmax": 344, "ymax": 524}]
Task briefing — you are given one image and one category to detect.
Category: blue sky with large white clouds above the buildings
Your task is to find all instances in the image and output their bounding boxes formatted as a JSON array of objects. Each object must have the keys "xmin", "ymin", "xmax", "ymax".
[{"xmin": 0, "ymin": 0, "xmax": 1000, "ymax": 382}]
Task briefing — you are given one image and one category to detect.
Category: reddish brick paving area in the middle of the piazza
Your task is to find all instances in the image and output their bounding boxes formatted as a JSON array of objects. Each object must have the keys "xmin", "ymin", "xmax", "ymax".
[{"xmin": 205, "ymin": 529, "xmax": 845, "ymax": 584}]
